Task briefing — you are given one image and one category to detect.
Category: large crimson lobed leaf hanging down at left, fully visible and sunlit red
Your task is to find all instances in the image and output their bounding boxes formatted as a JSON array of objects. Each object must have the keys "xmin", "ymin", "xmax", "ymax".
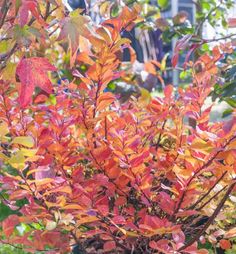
[{"xmin": 16, "ymin": 57, "xmax": 56, "ymax": 107}]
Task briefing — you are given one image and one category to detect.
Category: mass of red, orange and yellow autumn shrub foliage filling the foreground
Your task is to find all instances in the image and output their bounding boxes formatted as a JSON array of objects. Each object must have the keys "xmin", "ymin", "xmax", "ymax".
[{"xmin": 0, "ymin": 0, "xmax": 236, "ymax": 254}]
